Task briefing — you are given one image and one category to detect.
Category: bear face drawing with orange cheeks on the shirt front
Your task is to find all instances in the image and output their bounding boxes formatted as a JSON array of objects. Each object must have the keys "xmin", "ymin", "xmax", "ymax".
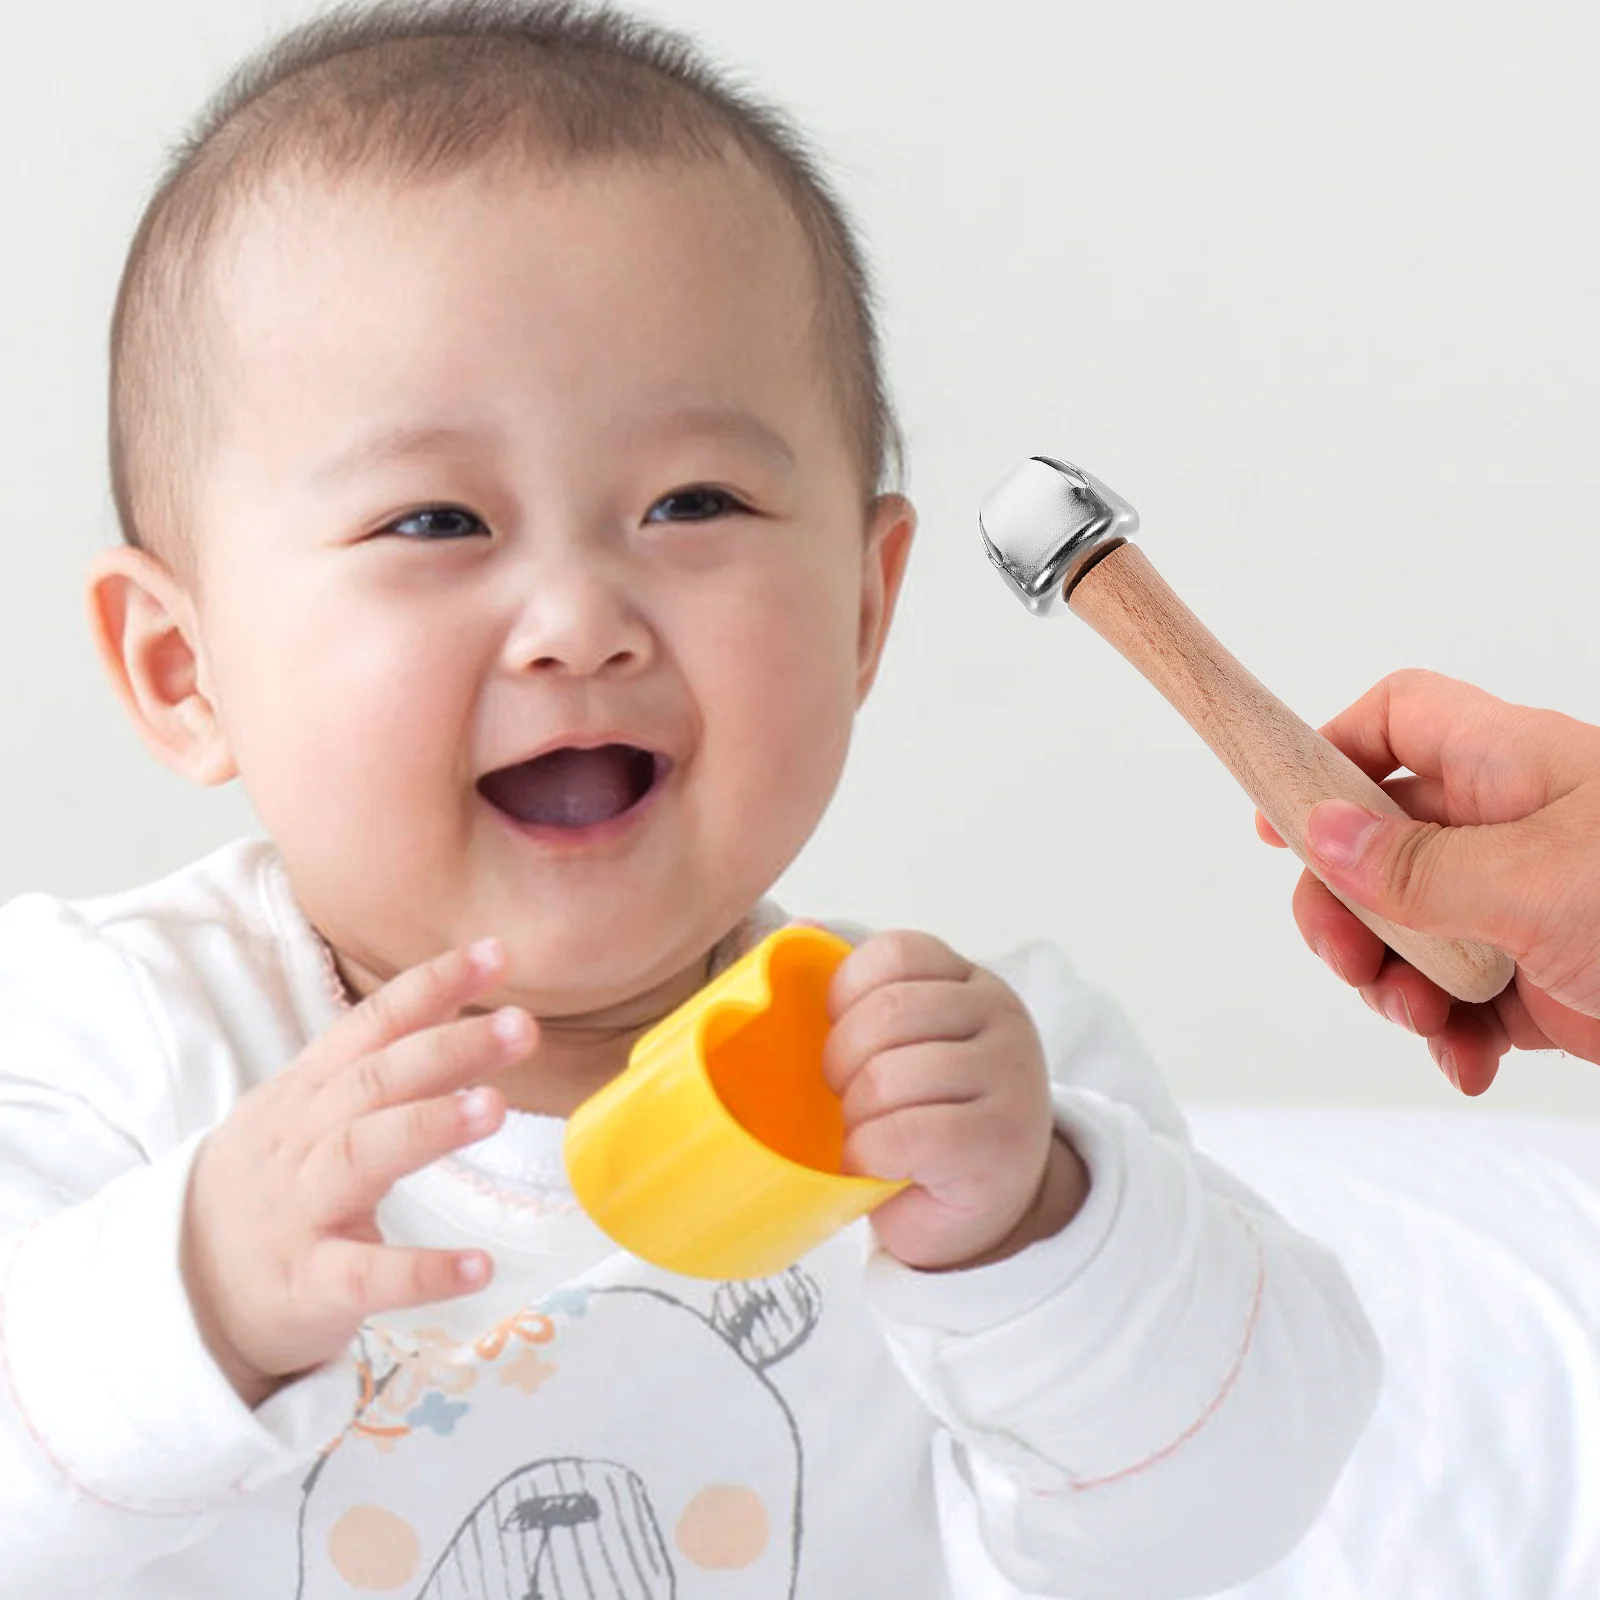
[{"xmin": 296, "ymin": 1267, "xmax": 821, "ymax": 1600}]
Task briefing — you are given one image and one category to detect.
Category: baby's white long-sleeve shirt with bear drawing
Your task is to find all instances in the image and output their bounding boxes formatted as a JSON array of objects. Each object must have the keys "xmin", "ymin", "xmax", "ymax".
[{"xmin": 0, "ymin": 840, "xmax": 1379, "ymax": 1600}]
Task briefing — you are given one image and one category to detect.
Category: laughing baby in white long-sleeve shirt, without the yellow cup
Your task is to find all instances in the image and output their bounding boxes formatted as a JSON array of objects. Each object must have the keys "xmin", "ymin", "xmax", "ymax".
[{"xmin": 0, "ymin": 0, "xmax": 1378, "ymax": 1600}]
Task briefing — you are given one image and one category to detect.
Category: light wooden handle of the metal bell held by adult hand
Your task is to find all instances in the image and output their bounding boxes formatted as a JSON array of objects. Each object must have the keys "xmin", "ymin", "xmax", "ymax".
[{"xmin": 1067, "ymin": 544, "xmax": 1512, "ymax": 1000}]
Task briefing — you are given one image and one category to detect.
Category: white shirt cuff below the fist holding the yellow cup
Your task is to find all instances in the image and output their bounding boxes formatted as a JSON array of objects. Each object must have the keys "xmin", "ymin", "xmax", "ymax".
[{"xmin": 867, "ymin": 1090, "xmax": 1264, "ymax": 1491}]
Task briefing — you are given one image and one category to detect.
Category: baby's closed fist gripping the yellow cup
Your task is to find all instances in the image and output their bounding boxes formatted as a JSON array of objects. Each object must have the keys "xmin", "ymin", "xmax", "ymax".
[{"xmin": 822, "ymin": 933, "xmax": 1090, "ymax": 1270}]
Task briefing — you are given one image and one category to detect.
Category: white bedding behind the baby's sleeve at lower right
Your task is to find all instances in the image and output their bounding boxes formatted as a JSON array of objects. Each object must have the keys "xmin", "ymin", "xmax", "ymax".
[{"xmin": 949, "ymin": 1107, "xmax": 1600, "ymax": 1600}]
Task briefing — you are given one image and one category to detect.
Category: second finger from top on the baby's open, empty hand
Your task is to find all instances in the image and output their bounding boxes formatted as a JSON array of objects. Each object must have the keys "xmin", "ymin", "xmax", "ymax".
[{"xmin": 312, "ymin": 1006, "xmax": 539, "ymax": 1134}]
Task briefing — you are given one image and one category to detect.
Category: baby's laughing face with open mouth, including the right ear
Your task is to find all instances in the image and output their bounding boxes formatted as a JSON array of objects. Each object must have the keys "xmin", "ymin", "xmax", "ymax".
[{"xmin": 180, "ymin": 162, "xmax": 910, "ymax": 1014}]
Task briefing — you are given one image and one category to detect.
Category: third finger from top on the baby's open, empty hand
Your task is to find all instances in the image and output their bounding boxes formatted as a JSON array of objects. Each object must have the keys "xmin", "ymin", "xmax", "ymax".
[{"xmin": 304, "ymin": 1085, "xmax": 506, "ymax": 1227}]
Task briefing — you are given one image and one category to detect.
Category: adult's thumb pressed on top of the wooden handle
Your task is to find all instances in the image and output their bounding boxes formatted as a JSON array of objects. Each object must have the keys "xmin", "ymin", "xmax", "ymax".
[{"xmin": 1306, "ymin": 800, "xmax": 1525, "ymax": 950}]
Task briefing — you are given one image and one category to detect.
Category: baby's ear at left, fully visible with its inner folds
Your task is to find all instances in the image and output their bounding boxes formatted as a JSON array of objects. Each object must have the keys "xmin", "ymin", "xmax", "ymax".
[{"xmin": 88, "ymin": 546, "xmax": 238, "ymax": 784}]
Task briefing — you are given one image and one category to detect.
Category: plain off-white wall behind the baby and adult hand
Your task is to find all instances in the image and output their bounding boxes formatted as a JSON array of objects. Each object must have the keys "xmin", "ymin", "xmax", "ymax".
[{"xmin": 0, "ymin": 0, "xmax": 1600, "ymax": 1115}]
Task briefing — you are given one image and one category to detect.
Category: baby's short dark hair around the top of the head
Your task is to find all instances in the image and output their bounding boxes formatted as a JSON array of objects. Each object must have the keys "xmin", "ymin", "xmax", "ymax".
[{"xmin": 110, "ymin": 0, "xmax": 899, "ymax": 555}]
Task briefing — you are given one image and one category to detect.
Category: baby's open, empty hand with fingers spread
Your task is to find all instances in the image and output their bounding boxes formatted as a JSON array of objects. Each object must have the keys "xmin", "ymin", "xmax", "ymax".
[{"xmin": 181, "ymin": 939, "xmax": 536, "ymax": 1408}]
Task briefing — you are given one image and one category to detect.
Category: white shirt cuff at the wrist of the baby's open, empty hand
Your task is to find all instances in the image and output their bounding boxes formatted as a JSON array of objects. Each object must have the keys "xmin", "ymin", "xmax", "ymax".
[{"xmin": 0, "ymin": 1133, "xmax": 357, "ymax": 1514}]
